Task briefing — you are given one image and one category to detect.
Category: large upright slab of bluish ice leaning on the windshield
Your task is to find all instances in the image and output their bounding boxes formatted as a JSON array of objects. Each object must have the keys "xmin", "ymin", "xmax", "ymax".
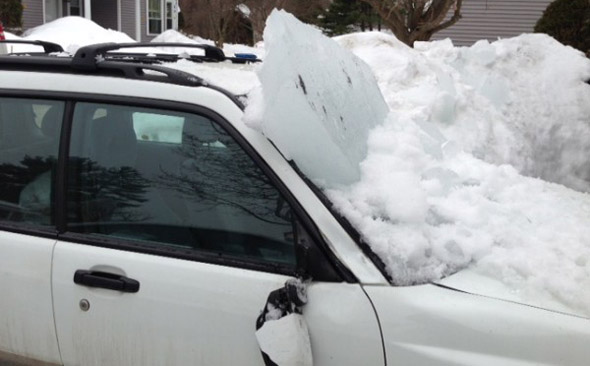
[{"xmin": 259, "ymin": 10, "xmax": 389, "ymax": 186}]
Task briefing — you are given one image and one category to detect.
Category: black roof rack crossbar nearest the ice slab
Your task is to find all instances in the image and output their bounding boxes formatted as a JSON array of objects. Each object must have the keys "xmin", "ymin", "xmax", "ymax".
[{"xmin": 72, "ymin": 42, "xmax": 226, "ymax": 70}]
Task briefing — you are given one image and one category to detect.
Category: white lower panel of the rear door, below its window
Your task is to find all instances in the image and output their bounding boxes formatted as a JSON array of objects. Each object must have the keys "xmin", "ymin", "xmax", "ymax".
[{"xmin": 0, "ymin": 231, "xmax": 61, "ymax": 364}]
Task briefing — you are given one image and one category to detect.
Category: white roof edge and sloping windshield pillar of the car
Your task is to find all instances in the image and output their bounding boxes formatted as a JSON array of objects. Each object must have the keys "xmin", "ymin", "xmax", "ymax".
[{"xmin": 0, "ymin": 71, "xmax": 388, "ymax": 285}]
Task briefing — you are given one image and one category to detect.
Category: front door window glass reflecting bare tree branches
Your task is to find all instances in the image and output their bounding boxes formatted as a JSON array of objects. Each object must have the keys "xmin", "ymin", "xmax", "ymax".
[{"xmin": 67, "ymin": 103, "xmax": 295, "ymax": 264}]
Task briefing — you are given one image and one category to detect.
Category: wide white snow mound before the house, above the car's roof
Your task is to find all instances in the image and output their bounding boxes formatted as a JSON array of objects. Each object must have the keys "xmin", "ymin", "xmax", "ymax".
[{"xmin": 23, "ymin": 16, "xmax": 135, "ymax": 54}]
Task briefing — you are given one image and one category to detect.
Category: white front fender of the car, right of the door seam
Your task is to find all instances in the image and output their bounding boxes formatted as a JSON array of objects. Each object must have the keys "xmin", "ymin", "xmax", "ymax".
[{"xmin": 365, "ymin": 285, "xmax": 590, "ymax": 366}]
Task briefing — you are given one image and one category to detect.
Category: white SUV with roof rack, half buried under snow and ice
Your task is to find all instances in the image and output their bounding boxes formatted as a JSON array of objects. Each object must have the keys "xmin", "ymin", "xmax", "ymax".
[{"xmin": 0, "ymin": 40, "xmax": 590, "ymax": 366}]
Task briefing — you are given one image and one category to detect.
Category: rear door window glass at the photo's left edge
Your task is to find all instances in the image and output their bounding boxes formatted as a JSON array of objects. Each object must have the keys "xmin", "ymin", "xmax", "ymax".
[{"xmin": 0, "ymin": 97, "xmax": 64, "ymax": 226}]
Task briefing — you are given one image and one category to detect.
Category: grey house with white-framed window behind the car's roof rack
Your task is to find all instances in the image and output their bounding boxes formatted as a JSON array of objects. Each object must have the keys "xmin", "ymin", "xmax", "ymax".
[{"xmin": 22, "ymin": 0, "xmax": 180, "ymax": 41}]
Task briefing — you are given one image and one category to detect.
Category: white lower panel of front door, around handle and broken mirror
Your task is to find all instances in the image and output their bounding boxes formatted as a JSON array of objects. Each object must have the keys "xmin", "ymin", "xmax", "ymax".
[{"xmin": 53, "ymin": 241, "xmax": 384, "ymax": 366}]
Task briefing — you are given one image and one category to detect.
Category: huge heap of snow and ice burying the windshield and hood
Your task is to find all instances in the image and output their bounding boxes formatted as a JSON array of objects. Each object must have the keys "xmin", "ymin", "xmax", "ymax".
[{"xmin": 247, "ymin": 12, "xmax": 590, "ymax": 315}]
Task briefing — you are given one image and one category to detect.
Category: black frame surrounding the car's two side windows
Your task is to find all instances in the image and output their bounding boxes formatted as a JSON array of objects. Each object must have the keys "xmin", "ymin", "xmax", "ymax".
[{"xmin": 0, "ymin": 88, "xmax": 358, "ymax": 283}]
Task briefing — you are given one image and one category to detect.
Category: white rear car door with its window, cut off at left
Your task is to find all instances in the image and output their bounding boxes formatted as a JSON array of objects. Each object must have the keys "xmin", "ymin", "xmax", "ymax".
[{"xmin": 0, "ymin": 96, "xmax": 64, "ymax": 365}]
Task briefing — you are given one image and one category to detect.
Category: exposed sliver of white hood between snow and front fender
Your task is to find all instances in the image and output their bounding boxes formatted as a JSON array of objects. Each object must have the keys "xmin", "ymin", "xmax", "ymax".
[{"xmin": 434, "ymin": 269, "xmax": 590, "ymax": 319}]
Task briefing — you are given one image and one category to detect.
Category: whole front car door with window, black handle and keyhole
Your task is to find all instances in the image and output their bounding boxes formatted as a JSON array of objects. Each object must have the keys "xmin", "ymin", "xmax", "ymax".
[{"xmin": 53, "ymin": 102, "xmax": 384, "ymax": 365}]
